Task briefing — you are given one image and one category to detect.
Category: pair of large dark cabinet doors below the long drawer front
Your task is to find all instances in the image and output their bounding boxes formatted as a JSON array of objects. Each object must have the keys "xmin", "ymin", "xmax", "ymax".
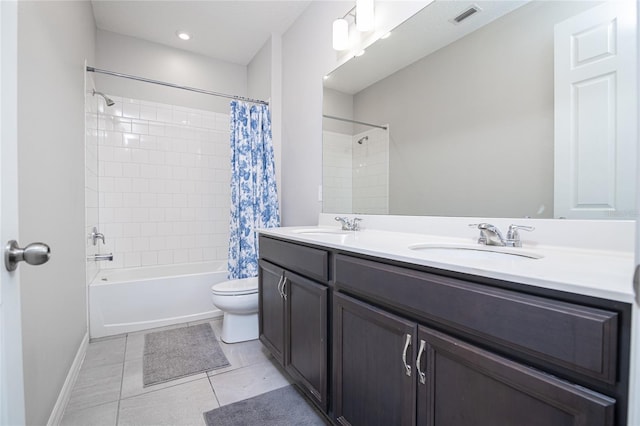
[{"xmin": 334, "ymin": 293, "xmax": 615, "ymax": 426}]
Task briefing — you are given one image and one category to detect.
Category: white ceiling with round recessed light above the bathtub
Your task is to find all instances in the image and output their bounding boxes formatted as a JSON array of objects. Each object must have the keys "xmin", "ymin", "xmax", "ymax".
[{"xmin": 92, "ymin": 0, "xmax": 310, "ymax": 65}]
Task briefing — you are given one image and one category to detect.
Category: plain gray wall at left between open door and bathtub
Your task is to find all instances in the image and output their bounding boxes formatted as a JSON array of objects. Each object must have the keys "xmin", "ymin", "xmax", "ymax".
[{"xmin": 18, "ymin": 1, "xmax": 95, "ymax": 425}]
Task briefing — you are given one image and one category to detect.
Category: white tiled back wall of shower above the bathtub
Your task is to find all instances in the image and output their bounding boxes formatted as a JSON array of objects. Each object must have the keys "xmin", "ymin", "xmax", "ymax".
[{"xmin": 87, "ymin": 96, "xmax": 230, "ymax": 269}]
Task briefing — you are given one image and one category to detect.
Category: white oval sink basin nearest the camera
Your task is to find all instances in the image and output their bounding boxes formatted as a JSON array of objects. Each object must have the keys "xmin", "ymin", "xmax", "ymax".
[{"xmin": 409, "ymin": 243, "xmax": 544, "ymax": 260}]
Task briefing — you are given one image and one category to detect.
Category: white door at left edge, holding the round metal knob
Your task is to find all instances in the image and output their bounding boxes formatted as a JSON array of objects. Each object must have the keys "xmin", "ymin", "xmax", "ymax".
[{"xmin": 0, "ymin": 1, "xmax": 25, "ymax": 425}]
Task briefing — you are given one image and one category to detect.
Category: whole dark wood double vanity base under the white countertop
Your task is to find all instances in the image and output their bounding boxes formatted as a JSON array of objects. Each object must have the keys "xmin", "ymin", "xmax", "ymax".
[{"xmin": 259, "ymin": 235, "xmax": 631, "ymax": 426}]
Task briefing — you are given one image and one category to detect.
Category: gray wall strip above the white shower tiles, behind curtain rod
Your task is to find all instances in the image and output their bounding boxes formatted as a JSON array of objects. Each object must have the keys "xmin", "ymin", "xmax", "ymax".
[{"xmin": 95, "ymin": 30, "xmax": 247, "ymax": 113}]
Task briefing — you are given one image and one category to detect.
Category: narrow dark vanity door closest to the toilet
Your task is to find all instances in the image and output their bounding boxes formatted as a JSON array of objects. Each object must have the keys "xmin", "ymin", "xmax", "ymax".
[{"xmin": 258, "ymin": 260, "xmax": 285, "ymax": 365}]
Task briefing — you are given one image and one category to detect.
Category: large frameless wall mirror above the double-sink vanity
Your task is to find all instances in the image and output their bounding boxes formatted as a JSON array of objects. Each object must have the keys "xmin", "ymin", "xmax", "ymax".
[{"xmin": 323, "ymin": 1, "xmax": 637, "ymax": 219}]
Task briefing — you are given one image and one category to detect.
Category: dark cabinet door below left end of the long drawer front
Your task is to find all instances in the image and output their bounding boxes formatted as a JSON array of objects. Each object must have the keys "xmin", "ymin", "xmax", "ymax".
[{"xmin": 333, "ymin": 293, "xmax": 418, "ymax": 426}]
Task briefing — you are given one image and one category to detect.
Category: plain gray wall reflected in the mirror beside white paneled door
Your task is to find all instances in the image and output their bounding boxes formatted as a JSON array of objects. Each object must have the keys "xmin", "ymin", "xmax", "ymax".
[{"xmin": 354, "ymin": 2, "xmax": 596, "ymax": 217}]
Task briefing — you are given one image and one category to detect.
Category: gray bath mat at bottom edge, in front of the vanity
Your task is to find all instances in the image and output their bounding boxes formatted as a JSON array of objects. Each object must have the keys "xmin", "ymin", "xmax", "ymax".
[{"xmin": 204, "ymin": 386, "xmax": 330, "ymax": 426}]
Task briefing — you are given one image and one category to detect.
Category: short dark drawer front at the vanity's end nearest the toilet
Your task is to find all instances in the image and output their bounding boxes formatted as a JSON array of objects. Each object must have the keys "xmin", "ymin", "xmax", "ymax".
[{"xmin": 260, "ymin": 236, "xmax": 329, "ymax": 282}]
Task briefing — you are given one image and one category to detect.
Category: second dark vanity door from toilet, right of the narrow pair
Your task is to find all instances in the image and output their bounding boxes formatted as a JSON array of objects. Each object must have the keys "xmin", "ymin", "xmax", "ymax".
[{"xmin": 284, "ymin": 271, "xmax": 328, "ymax": 410}]
